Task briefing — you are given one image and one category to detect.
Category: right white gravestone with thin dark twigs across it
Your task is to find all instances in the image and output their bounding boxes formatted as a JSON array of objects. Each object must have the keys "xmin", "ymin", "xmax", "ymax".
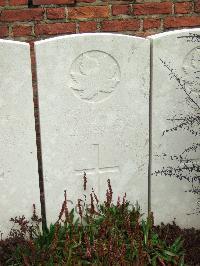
[{"xmin": 150, "ymin": 29, "xmax": 200, "ymax": 228}]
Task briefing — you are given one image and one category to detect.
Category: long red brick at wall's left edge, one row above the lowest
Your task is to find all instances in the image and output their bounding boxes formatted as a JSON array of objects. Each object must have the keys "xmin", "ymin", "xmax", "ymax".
[{"xmin": 0, "ymin": 8, "xmax": 44, "ymax": 22}]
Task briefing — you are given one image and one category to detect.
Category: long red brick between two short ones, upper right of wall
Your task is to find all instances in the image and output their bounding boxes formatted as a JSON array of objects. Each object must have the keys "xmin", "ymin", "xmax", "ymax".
[{"xmin": 133, "ymin": 2, "xmax": 172, "ymax": 15}]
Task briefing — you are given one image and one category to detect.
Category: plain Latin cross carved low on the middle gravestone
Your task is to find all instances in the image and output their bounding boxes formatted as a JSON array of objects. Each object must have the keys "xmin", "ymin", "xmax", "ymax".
[{"xmin": 75, "ymin": 144, "xmax": 120, "ymax": 192}]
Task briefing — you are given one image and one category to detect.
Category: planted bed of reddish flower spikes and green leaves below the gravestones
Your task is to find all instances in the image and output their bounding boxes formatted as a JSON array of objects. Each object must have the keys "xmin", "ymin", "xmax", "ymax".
[{"xmin": 0, "ymin": 178, "xmax": 200, "ymax": 266}]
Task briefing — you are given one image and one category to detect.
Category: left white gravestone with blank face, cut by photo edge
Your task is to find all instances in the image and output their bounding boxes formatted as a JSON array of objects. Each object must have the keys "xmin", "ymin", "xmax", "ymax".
[{"xmin": 0, "ymin": 40, "xmax": 40, "ymax": 237}]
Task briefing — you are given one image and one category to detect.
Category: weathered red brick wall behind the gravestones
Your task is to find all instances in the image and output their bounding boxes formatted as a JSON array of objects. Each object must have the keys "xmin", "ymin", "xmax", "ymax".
[{"xmin": 0, "ymin": 0, "xmax": 200, "ymax": 41}]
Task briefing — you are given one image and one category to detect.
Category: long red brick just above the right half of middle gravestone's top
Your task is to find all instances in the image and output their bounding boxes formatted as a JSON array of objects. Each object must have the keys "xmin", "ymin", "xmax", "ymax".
[{"xmin": 102, "ymin": 19, "xmax": 140, "ymax": 31}]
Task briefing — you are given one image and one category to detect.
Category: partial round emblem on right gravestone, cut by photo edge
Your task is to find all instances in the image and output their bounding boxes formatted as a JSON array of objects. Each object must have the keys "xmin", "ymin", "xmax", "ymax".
[{"xmin": 182, "ymin": 46, "xmax": 200, "ymax": 94}]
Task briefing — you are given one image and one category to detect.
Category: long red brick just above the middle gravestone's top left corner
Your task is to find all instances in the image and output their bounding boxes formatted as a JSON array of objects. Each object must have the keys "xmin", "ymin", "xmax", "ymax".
[{"xmin": 35, "ymin": 22, "xmax": 76, "ymax": 35}]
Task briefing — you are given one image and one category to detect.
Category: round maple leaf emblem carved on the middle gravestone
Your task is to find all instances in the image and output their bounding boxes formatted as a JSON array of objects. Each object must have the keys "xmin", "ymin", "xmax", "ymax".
[{"xmin": 70, "ymin": 50, "xmax": 120, "ymax": 102}]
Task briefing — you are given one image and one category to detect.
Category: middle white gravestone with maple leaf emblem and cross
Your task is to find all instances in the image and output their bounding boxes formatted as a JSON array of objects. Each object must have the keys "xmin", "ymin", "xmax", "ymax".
[{"xmin": 35, "ymin": 34, "xmax": 150, "ymax": 222}]
